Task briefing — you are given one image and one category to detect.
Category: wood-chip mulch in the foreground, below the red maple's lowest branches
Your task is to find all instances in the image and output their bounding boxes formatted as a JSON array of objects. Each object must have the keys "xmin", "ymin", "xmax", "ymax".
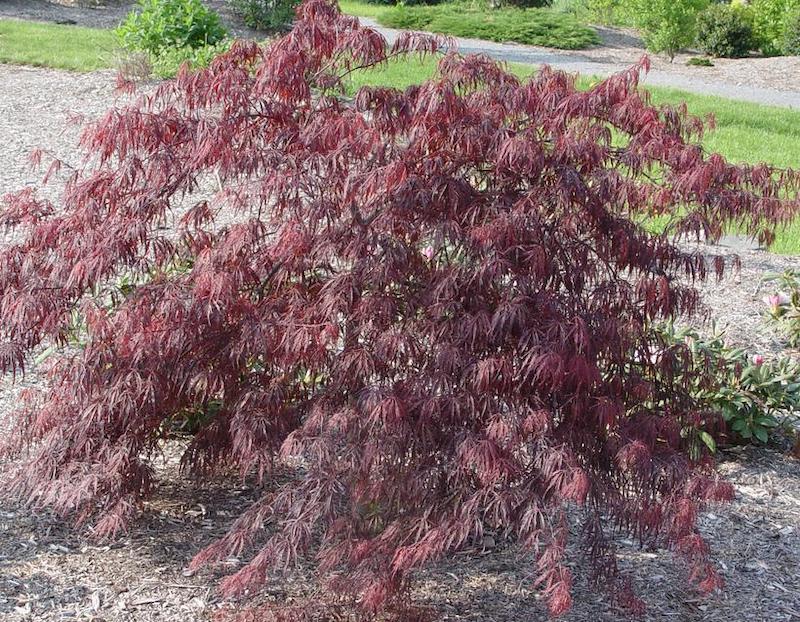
[{"xmin": 0, "ymin": 442, "xmax": 800, "ymax": 622}]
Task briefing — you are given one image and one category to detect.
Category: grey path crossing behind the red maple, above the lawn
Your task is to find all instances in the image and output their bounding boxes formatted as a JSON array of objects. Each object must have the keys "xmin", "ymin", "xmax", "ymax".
[{"xmin": 359, "ymin": 17, "xmax": 800, "ymax": 109}]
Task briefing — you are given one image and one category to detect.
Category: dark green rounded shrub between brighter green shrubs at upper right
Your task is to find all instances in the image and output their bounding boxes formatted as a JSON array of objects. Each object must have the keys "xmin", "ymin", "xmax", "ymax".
[{"xmin": 696, "ymin": 4, "xmax": 753, "ymax": 58}]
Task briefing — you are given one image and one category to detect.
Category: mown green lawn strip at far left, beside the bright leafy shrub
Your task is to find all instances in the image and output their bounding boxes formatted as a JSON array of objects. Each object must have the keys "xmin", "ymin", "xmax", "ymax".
[{"xmin": 0, "ymin": 19, "xmax": 117, "ymax": 71}]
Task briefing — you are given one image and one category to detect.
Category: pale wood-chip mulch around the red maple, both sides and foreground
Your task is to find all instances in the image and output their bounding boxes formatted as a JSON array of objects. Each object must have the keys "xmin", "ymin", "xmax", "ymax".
[{"xmin": 0, "ymin": 66, "xmax": 800, "ymax": 622}]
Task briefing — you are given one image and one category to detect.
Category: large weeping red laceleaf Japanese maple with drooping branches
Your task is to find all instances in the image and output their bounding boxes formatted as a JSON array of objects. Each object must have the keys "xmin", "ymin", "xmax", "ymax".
[{"xmin": 0, "ymin": 0, "xmax": 798, "ymax": 615}]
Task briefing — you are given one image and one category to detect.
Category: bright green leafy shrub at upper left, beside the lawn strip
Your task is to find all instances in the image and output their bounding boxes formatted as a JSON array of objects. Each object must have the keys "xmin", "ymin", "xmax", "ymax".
[{"xmin": 116, "ymin": 0, "xmax": 227, "ymax": 54}]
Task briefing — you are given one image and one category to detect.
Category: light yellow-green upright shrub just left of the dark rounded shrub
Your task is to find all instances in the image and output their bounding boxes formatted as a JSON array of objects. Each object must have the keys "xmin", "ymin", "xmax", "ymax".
[{"xmin": 631, "ymin": 0, "xmax": 708, "ymax": 60}]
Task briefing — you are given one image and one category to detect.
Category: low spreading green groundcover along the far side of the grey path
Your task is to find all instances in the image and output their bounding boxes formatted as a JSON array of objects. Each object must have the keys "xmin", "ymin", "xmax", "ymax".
[{"xmin": 341, "ymin": 0, "xmax": 600, "ymax": 50}]
